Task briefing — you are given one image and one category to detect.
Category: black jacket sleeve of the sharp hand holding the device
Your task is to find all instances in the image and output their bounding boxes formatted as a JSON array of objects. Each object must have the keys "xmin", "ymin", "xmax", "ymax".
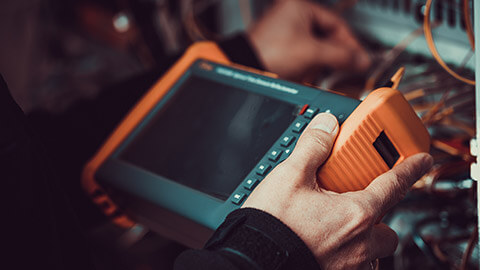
[{"xmin": 175, "ymin": 208, "xmax": 319, "ymax": 270}]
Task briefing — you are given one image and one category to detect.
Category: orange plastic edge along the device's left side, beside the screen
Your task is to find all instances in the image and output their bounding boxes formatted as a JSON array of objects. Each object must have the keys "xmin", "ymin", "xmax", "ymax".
[{"xmin": 82, "ymin": 42, "xmax": 231, "ymax": 228}]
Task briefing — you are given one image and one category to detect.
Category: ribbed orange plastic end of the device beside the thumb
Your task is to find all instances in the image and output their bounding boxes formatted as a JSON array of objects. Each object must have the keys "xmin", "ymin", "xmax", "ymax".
[{"xmin": 317, "ymin": 88, "xmax": 430, "ymax": 192}]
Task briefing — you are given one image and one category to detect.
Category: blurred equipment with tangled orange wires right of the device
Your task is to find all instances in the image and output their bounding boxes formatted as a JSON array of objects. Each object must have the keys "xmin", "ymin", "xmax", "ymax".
[{"xmin": 329, "ymin": 0, "xmax": 480, "ymax": 269}]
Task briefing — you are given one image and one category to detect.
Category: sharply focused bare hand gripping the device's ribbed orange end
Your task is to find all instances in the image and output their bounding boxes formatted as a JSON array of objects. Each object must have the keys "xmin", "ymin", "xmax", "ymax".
[{"xmin": 242, "ymin": 113, "xmax": 432, "ymax": 269}]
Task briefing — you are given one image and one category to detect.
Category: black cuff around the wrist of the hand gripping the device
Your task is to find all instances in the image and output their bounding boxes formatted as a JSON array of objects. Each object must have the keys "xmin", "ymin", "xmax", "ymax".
[{"xmin": 205, "ymin": 208, "xmax": 319, "ymax": 269}]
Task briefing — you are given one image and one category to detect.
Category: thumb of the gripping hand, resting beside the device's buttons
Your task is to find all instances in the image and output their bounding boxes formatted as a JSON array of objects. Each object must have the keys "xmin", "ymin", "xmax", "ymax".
[{"xmin": 285, "ymin": 113, "xmax": 338, "ymax": 173}]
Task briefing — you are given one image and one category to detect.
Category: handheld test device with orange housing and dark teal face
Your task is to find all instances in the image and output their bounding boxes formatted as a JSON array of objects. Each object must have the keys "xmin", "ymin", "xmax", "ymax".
[{"xmin": 82, "ymin": 42, "xmax": 429, "ymax": 247}]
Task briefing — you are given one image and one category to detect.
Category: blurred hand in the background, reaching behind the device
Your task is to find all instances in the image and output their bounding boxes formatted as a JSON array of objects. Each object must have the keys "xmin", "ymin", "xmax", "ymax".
[{"xmin": 248, "ymin": 0, "xmax": 371, "ymax": 81}]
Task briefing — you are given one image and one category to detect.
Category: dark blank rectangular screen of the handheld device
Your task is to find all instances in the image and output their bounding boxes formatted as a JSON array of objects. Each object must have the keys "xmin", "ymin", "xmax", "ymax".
[{"xmin": 120, "ymin": 76, "xmax": 296, "ymax": 200}]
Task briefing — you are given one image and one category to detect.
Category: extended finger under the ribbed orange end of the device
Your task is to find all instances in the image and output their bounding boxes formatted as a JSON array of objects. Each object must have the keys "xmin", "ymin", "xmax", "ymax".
[{"xmin": 357, "ymin": 153, "xmax": 433, "ymax": 217}]
